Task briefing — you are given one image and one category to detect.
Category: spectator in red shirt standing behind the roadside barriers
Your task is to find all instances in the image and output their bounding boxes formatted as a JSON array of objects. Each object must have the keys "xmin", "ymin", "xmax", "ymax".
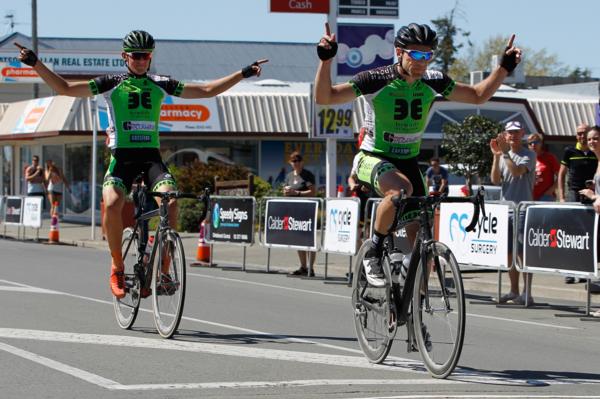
[{"xmin": 527, "ymin": 133, "xmax": 560, "ymax": 202}]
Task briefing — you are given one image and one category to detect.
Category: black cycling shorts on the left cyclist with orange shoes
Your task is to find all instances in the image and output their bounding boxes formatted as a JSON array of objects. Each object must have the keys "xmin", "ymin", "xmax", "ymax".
[{"xmin": 102, "ymin": 148, "xmax": 177, "ymax": 194}]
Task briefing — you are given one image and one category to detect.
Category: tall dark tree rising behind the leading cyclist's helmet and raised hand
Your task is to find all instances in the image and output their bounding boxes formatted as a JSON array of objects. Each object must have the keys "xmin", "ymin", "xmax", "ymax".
[{"xmin": 431, "ymin": 0, "xmax": 472, "ymax": 73}]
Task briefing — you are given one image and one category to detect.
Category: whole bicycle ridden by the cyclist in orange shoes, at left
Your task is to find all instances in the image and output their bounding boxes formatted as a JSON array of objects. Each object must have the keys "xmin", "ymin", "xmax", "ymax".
[{"xmin": 113, "ymin": 178, "xmax": 210, "ymax": 338}]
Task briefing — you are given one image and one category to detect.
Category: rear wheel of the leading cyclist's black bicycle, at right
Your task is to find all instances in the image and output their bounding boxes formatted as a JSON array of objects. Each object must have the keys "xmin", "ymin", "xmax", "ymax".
[{"xmin": 352, "ymin": 240, "xmax": 396, "ymax": 363}]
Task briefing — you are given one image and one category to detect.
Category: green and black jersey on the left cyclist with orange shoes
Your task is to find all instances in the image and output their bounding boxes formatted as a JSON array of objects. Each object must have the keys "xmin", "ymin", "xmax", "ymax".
[{"xmin": 89, "ymin": 73, "xmax": 184, "ymax": 149}]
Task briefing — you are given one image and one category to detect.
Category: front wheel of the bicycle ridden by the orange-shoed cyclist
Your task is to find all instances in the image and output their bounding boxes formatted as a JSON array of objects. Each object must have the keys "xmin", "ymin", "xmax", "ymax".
[{"xmin": 152, "ymin": 230, "xmax": 185, "ymax": 338}]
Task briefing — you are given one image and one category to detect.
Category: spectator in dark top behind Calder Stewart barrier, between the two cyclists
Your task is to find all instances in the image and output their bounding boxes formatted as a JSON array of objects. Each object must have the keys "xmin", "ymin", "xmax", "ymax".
[{"xmin": 283, "ymin": 151, "xmax": 316, "ymax": 277}]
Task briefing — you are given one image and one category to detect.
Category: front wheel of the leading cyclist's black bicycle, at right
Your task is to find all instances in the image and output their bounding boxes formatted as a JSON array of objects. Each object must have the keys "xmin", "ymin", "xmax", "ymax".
[{"xmin": 413, "ymin": 242, "xmax": 466, "ymax": 378}]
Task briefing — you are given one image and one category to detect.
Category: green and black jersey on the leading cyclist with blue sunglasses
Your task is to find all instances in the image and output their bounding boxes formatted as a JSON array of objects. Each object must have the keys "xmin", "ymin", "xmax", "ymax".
[{"xmin": 349, "ymin": 64, "xmax": 456, "ymax": 159}]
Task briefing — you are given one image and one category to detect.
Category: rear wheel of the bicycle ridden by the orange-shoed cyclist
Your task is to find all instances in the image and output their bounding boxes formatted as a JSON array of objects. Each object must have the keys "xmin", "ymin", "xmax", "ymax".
[{"xmin": 113, "ymin": 227, "xmax": 140, "ymax": 330}]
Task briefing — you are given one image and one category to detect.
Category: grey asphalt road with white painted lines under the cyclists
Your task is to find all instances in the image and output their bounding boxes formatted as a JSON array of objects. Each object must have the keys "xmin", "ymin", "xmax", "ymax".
[{"xmin": 0, "ymin": 240, "xmax": 600, "ymax": 398}]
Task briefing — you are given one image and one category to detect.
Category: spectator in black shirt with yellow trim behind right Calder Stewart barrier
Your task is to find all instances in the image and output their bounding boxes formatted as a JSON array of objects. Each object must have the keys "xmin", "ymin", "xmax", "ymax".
[{"xmin": 558, "ymin": 123, "xmax": 598, "ymax": 284}]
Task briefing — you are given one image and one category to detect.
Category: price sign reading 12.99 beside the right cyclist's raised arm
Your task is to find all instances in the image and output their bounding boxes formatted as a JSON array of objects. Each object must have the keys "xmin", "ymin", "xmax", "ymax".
[{"xmin": 313, "ymin": 103, "xmax": 354, "ymax": 139}]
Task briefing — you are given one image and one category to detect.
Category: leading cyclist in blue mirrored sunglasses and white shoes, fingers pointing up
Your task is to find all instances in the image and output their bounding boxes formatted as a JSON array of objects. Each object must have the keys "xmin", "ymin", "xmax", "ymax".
[{"xmin": 315, "ymin": 23, "xmax": 521, "ymax": 287}]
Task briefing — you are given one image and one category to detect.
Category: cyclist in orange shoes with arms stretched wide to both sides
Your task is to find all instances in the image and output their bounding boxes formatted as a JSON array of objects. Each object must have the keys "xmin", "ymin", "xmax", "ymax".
[{"xmin": 15, "ymin": 30, "xmax": 267, "ymax": 298}]
